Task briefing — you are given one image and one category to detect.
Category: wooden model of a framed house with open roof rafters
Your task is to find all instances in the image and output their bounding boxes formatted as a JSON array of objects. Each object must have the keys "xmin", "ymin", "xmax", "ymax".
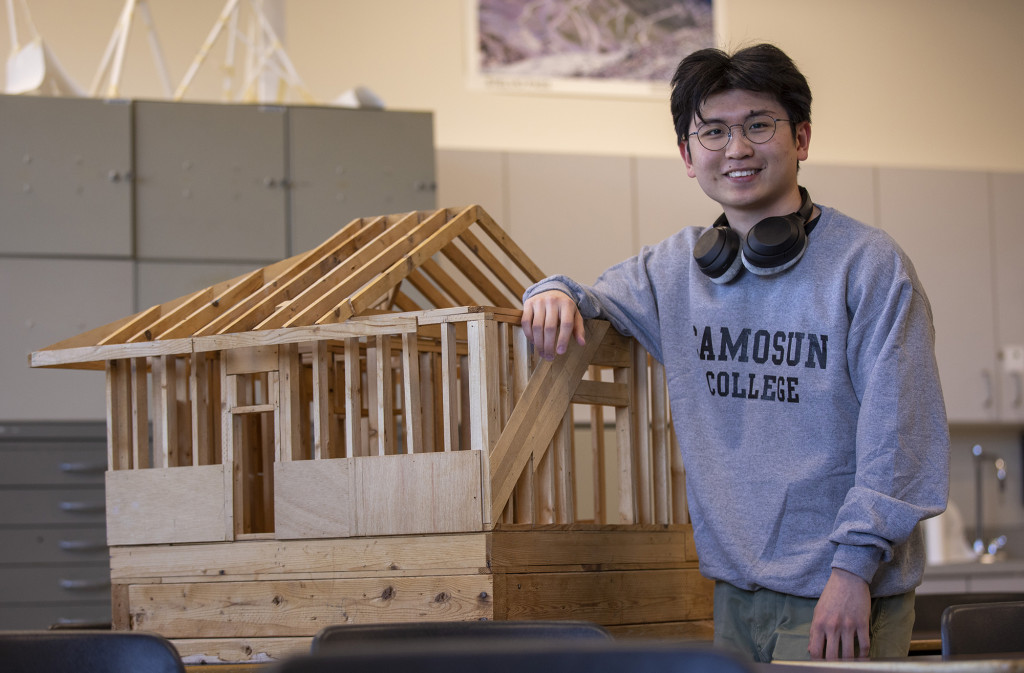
[{"xmin": 31, "ymin": 206, "xmax": 712, "ymax": 661}]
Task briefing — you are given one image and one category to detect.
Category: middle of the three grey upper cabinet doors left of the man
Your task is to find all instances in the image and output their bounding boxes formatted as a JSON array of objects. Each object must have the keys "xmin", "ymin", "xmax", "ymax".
[{"xmin": 135, "ymin": 101, "xmax": 288, "ymax": 261}]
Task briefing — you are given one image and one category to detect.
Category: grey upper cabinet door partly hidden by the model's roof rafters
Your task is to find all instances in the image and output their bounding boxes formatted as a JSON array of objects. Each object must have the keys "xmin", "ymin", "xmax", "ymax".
[{"xmin": 288, "ymin": 108, "xmax": 436, "ymax": 253}]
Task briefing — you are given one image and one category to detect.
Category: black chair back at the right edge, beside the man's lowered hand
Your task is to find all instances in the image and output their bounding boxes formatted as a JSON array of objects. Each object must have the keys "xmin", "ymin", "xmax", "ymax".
[{"xmin": 940, "ymin": 600, "xmax": 1024, "ymax": 659}]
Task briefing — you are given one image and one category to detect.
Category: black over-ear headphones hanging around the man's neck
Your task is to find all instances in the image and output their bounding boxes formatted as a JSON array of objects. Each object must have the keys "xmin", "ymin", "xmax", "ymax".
[{"xmin": 693, "ymin": 187, "xmax": 814, "ymax": 285}]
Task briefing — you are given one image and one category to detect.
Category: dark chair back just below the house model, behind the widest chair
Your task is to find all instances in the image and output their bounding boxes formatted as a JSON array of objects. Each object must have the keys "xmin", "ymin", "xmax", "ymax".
[{"xmin": 312, "ymin": 620, "xmax": 611, "ymax": 653}]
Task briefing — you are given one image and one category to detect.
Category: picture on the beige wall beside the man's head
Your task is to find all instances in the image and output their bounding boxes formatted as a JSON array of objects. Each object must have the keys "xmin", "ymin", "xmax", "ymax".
[{"xmin": 467, "ymin": 0, "xmax": 715, "ymax": 96}]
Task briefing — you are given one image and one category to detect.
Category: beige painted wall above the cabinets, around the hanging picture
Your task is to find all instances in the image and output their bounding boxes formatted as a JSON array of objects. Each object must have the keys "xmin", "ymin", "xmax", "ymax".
[{"xmin": 0, "ymin": 0, "xmax": 1024, "ymax": 171}]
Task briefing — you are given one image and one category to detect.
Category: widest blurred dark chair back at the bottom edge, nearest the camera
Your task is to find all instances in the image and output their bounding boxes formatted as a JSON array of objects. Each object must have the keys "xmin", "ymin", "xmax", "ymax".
[{"xmin": 270, "ymin": 638, "xmax": 754, "ymax": 673}]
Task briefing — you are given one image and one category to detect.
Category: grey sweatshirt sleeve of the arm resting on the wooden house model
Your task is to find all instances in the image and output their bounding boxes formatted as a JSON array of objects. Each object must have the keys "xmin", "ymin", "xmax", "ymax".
[{"xmin": 523, "ymin": 247, "xmax": 664, "ymax": 362}]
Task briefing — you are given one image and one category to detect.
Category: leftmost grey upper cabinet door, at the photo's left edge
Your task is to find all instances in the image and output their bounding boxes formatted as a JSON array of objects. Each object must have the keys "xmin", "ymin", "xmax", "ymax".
[{"xmin": 0, "ymin": 91, "xmax": 132, "ymax": 257}]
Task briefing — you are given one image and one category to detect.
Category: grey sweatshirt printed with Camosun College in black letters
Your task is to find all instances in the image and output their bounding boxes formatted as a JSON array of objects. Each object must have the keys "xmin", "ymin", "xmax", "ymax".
[{"xmin": 525, "ymin": 207, "xmax": 949, "ymax": 597}]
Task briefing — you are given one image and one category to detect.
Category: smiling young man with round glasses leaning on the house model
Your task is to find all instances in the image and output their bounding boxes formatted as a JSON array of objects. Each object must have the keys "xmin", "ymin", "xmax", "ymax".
[{"xmin": 522, "ymin": 44, "xmax": 949, "ymax": 661}]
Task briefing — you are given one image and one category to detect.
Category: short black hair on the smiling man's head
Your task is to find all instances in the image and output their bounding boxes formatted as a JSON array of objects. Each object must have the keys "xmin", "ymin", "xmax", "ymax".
[{"xmin": 672, "ymin": 44, "xmax": 811, "ymax": 144}]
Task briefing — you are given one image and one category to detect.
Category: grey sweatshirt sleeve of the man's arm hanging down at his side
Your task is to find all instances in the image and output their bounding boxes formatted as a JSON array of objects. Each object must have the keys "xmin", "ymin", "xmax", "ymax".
[{"xmin": 830, "ymin": 260, "xmax": 949, "ymax": 583}]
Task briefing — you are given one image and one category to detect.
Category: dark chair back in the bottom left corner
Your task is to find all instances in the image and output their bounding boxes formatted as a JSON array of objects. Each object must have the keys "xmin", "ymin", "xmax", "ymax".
[{"xmin": 0, "ymin": 630, "xmax": 185, "ymax": 673}]
